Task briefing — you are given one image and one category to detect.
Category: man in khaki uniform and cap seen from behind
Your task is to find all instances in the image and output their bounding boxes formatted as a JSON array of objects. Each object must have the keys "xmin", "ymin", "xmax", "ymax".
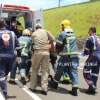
[{"xmin": 30, "ymin": 24, "xmax": 54, "ymax": 95}]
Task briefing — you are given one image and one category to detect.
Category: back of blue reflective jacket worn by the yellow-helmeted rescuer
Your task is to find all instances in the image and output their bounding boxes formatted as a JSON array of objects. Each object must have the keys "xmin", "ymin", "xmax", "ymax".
[{"xmin": 63, "ymin": 32, "xmax": 78, "ymax": 55}]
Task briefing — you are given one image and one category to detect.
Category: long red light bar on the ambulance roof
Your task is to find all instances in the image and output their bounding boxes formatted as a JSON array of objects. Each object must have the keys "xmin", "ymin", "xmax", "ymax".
[{"xmin": 3, "ymin": 5, "xmax": 29, "ymax": 11}]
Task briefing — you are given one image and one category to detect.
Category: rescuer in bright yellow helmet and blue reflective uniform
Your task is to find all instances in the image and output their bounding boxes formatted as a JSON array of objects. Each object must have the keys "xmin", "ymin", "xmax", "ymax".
[{"xmin": 50, "ymin": 20, "xmax": 79, "ymax": 96}]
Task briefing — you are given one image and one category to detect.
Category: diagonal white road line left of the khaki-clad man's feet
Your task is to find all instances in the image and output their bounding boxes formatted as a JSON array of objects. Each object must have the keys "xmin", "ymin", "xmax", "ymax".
[{"xmin": 14, "ymin": 79, "xmax": 42, "ymax": 100}]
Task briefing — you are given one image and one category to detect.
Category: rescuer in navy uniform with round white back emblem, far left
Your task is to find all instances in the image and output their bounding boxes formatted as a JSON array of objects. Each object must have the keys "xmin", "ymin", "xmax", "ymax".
[{"xmin": 0, "ymin": 19, "xmax": 18, "ymax": 98}]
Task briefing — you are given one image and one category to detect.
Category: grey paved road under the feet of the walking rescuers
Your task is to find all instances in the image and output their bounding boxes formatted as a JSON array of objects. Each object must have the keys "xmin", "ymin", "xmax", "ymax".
[{"xmin": 0, "ymin": 56, "xmax": 100, "ymax": 100}]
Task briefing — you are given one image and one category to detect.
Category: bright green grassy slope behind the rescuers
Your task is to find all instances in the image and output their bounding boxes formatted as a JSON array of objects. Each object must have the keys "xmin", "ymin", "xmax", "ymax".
[{"xmin": 44, "ymin": 0, "xmax": 100, "ymax": 38}]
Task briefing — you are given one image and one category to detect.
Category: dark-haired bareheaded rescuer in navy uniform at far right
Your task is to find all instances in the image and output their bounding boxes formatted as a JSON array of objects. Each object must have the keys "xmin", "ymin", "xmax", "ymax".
[{"xmin": 83, "ymin": 27, "xmax": 100, "ymax": 94}]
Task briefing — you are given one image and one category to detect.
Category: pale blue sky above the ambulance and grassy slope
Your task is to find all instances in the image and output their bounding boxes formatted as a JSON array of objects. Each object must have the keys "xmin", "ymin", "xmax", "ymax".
[{"xmin": 0, "ymin": 0, "xmax": 89, "ymax": 10}]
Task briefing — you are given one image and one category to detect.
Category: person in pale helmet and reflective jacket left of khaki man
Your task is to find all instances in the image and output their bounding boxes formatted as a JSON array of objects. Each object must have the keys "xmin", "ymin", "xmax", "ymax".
[{"xmin": 18, "ymin": 29, "xmax": 32, "ymax": 85}]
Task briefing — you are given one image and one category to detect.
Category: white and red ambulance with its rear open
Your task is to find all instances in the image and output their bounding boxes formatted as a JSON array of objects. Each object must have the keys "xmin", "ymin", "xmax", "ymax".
[{"xmin": 0, "ymin": 4, "xmax": 43, "ymax": 29}]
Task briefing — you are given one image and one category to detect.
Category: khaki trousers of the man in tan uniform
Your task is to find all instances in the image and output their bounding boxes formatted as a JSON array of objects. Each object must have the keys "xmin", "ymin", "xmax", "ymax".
[{"xmin": 30, "ymin": 51, "xmax": 50, "ymax": 91}]
